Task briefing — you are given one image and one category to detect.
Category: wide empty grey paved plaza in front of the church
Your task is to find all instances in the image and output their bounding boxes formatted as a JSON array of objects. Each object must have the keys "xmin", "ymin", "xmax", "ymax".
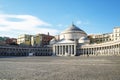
[{"xmin": 0, "ymin": 56, "xmax": 120, "ymax": 80}]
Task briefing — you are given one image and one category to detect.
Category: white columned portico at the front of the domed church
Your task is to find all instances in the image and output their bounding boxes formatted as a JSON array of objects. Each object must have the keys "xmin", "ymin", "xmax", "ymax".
[{"xmin": 53, "ymin": 44, "xmax": 76, "ymax": 56}]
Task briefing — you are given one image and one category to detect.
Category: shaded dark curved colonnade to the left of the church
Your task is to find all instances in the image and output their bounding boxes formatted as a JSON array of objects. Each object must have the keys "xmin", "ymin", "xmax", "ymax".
[{"xmin": 0, "ymin": 46, "xmax": 52, "ymax": 56}]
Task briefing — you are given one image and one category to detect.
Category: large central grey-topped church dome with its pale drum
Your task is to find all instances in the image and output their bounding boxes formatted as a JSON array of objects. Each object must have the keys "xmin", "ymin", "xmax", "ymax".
[{"xmin": 60, "ymin": 24, "xmax": 87, "ymax": 40}]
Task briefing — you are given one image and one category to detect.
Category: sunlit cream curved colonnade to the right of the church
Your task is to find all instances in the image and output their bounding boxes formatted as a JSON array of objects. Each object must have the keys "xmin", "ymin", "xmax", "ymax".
[{"xmin": 77, "ymin": 41, "xmax": 120, "ymax": 56}]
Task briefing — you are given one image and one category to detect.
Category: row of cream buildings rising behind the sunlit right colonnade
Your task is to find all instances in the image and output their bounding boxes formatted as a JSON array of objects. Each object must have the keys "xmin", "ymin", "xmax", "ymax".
[{"xmin": 88, "ymin": 27, "xmax": 120, "ymax": 44}]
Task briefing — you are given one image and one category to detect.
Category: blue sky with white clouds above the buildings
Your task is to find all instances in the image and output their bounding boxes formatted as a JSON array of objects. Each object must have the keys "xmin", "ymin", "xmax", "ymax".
[{"xmin": 0, "ymin": 0, "xmax": 120, "ymax": 37}]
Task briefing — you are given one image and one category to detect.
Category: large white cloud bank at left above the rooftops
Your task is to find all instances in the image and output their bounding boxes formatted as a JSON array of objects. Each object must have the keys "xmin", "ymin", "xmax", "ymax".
[{"xmin": 0, "ymin": 14, "xmax": 58, "ymax": 37}]
